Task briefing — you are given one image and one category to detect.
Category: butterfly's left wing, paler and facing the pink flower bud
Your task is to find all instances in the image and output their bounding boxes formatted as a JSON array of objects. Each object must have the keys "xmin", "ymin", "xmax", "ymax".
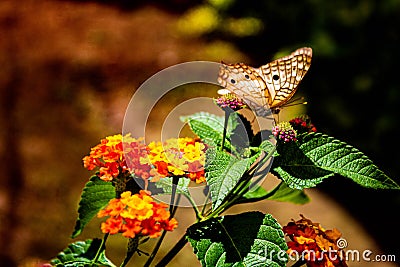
[{"xmin": 218, "ymin": 63, "xmax": 271, "ymax": 117}]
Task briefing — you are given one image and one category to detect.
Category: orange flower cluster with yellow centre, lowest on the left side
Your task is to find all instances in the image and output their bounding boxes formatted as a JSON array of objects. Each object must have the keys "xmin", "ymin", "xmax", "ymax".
[{"xmin": 97, "ymin": 190, "xmax": 178, "ymax": 238}]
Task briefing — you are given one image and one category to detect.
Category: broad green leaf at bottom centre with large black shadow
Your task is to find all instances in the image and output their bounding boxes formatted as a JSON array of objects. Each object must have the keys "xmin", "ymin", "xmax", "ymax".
[{"xmin": 187, "ymin": 212, "xmax": 288, "ymax": 267}]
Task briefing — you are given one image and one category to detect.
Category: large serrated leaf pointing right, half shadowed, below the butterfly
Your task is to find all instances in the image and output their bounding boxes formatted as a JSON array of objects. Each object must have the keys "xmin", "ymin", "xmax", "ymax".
[{"xmin": 273, "ymin": 133, "xmax": 400, "ymax": 189}]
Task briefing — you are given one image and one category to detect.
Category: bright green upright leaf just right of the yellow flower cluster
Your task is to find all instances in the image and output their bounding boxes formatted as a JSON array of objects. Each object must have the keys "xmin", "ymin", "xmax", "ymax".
[{"xmin": 205, "ymin": 148, "xmax": 255, "ymax": 209}]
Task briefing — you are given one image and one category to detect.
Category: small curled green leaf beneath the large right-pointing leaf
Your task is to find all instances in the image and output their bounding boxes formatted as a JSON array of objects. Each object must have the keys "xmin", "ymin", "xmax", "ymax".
[{"xmin": 237, "ymin": 182, "xmax": 310, "ymax": 204}]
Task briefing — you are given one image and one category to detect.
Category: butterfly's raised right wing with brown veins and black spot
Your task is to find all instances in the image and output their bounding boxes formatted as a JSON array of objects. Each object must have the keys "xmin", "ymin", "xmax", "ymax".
[{"xmin": 254, "ymin": 47, "xmax": 312, "ymax": 109}]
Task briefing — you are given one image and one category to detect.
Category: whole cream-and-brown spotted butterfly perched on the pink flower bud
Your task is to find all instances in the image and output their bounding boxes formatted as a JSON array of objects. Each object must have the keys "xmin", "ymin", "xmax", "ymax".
[{"xmin": 218, "ymin": 47, "xmax": 312, "ymax": 117}]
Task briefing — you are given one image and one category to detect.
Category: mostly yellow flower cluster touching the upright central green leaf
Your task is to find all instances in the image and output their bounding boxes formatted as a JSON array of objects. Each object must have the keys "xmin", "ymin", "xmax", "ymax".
[{"xmin": 141, "ymin": 137, "xmax": 206, "ymax": 183}]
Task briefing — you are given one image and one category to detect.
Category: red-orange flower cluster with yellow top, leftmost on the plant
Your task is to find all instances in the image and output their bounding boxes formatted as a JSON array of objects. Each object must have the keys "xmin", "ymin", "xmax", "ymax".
[{"xmin": 83, "ymin": 134, "xmax": 151, "ymax": 181}]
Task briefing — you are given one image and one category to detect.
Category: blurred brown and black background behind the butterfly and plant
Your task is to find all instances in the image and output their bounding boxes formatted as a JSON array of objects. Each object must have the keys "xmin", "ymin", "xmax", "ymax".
[{"xmin": 0, "ymin": 0, "xmax": 400, "ymax": 267}]
